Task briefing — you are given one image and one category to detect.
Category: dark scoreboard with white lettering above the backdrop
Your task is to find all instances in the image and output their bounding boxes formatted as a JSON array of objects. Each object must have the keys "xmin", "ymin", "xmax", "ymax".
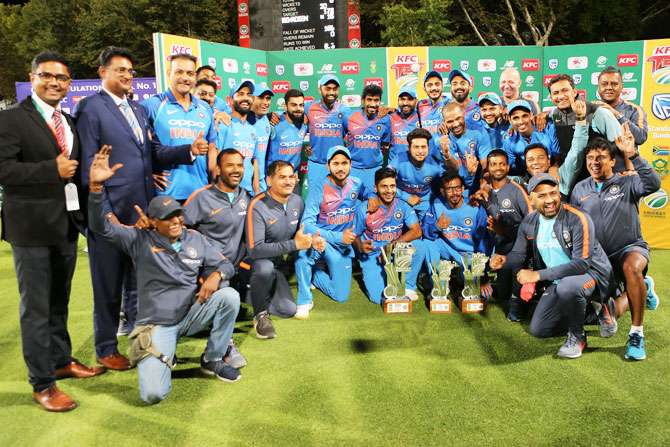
[{"xmin": 281, "ymin": 0, "xmax": 337, "ymax": 51}]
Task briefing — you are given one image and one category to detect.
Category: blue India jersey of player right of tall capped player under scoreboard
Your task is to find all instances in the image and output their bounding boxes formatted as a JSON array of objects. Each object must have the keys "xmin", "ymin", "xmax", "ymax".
[{"xmin": 343, "ymin": 109, "xmax": 391, "ymax": 169}]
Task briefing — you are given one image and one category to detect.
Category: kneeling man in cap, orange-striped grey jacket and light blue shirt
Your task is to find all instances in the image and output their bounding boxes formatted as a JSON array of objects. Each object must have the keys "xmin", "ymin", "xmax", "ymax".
[{"xmin": 490, "ymin": 173, "xmax": 612, "ymax": 358}]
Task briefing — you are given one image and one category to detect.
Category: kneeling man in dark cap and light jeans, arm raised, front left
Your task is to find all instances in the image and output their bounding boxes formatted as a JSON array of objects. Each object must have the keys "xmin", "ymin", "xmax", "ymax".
[{"xmin": 88, "ymin": 146, "xmax": 241, "ymax": 404}]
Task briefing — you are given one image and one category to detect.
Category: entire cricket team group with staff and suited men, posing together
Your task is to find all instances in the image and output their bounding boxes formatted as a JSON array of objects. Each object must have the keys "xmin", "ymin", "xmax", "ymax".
[{"xmin": 0, "ymin": 47, "xmax": 660, "ymax": 411}]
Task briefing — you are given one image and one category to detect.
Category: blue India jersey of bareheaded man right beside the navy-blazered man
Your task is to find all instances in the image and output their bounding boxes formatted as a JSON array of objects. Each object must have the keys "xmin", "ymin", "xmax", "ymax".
[{"xmin": 142, "ymin": 89, "xmax": 216, "ymax": 200}]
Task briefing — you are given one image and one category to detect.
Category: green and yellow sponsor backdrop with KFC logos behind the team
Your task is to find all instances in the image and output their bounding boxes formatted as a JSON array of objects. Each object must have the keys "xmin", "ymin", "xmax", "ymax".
[{"xmin": 154, "ymin": 34, "xmax": 670, "ymax": 248}]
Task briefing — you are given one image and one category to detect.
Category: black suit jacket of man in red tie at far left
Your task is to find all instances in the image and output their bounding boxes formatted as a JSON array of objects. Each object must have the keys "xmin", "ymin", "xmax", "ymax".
[{"xmin": 0, "ymin": 97, "xmax": 86, "ymax": 247}]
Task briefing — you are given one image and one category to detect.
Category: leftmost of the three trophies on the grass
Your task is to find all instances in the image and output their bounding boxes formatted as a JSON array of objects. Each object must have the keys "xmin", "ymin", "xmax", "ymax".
[{"xmin": 382, "ymin": 242, "xmax": 416, "ymax": 314}]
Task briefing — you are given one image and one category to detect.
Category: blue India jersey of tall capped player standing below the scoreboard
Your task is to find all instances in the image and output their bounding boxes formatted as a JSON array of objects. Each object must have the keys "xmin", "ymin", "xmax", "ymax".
[{"xmin": 305, "ymin": 101, "xmax": 351, "ymax": 164}]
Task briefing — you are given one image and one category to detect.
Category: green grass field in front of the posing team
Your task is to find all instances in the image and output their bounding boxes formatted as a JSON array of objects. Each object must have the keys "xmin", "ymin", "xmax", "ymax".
[{"xmin": 0, "ymin": 236, "xmax": 670, "ymax": 447}]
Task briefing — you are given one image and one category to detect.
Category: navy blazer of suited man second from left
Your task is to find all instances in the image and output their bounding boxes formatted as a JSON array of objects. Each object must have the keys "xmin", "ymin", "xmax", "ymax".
[{"xmin": 73, "ymin": 90, "xmax": 192, "ymax": 225}]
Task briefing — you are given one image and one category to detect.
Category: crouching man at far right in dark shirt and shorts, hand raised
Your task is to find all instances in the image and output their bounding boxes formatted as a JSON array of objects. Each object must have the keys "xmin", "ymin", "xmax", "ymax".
[{"xmin": 571, "ymin": 133, "xmax": 661, "ymax": 360}]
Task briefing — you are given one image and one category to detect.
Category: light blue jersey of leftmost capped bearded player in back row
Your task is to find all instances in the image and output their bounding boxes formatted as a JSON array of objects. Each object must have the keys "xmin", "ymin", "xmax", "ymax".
[{"xmin": 216, "ymin": 116, "xmax": 258, "ymax": 195}]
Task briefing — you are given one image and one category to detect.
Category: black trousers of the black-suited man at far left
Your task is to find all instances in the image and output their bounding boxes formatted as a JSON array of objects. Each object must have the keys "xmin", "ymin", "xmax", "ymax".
[{"xmin": 12, "ymin": 241, "xmax": 77, "ymax": 392}]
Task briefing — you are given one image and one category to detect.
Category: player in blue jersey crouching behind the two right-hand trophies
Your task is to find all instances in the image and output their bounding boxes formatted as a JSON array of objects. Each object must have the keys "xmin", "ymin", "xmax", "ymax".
[{"xmin": 421, "ymin": 170, "xmax": 492, "ymax": 299}]
